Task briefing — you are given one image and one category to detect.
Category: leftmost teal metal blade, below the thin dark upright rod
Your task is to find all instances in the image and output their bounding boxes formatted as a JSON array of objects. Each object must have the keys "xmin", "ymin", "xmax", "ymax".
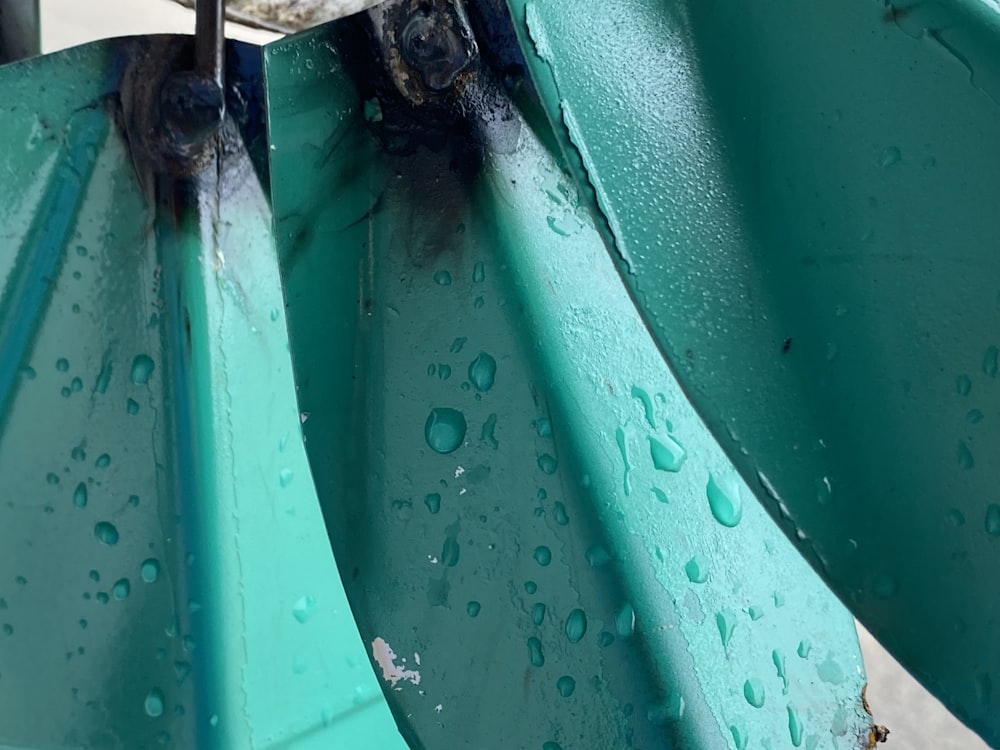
[{"xmin": 0, "ymin": 37, "xmax": 401, "ymax": 748}]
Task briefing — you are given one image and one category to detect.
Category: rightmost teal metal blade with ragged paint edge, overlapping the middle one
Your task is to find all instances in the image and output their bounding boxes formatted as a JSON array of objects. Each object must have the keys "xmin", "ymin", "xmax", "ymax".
[{"xmin": 508, "ymin": 0, "xmax": 1000, "ymax": 745}]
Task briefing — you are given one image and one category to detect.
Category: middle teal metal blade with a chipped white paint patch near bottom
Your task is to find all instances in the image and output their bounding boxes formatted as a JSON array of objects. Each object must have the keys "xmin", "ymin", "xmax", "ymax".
[{"xmin": 265, "ymin": 23, "xmax": 870, "ymax": 750}]
